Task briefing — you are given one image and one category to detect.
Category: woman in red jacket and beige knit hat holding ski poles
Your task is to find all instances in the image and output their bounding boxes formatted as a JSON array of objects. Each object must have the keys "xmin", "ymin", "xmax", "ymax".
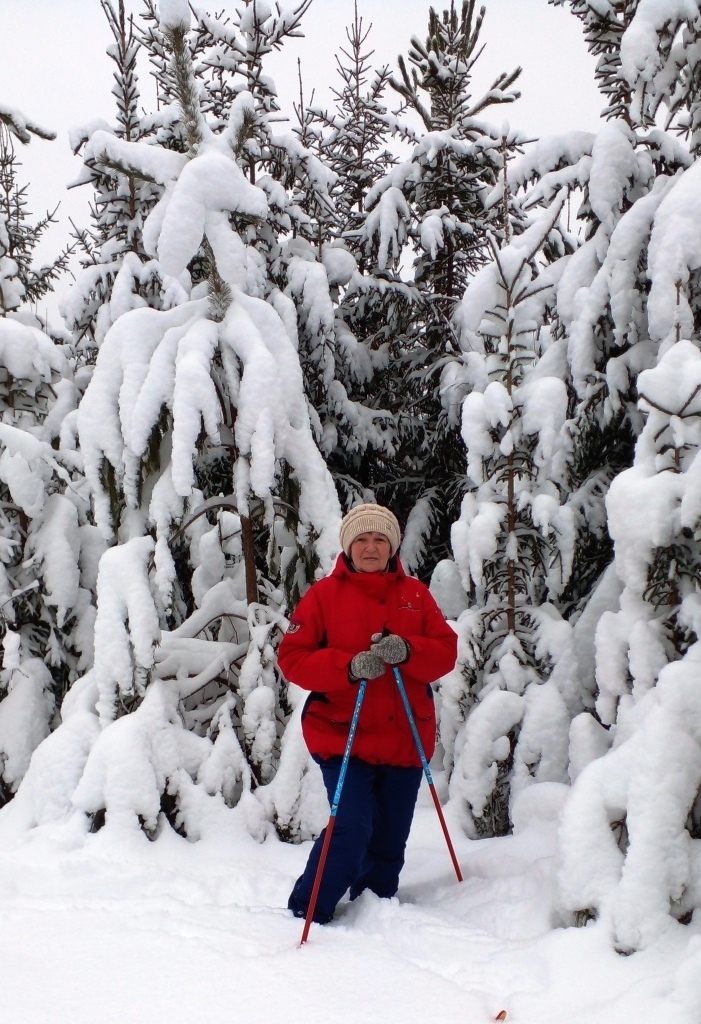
[{"xmin": 278, "ymin": 505, "xmax": 457, "ymax": 924}]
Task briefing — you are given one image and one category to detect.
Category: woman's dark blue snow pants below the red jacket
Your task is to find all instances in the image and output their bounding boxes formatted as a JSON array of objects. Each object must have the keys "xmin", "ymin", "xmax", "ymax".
[{"xmin": 288, "ymin": 757, "xmax": 423, "ymax": 925}]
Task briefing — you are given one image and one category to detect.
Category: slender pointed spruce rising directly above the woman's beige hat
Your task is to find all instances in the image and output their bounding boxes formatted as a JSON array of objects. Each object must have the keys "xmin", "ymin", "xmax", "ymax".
[{"xmin": 296, "ymin": 5, "xmax": 409, "ymax": 507}]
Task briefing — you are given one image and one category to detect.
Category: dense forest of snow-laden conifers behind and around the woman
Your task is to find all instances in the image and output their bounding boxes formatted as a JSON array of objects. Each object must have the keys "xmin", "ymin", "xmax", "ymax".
[{"xmin": 0, "ymin": 0, "xmax": 701, "ymax": 953}]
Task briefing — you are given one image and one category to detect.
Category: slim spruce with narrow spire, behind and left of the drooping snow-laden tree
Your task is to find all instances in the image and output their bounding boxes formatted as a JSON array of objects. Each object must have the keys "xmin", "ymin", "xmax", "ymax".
[{"xmin": 61, "ymin": 0, "xmax": 169, "ymax": 360}]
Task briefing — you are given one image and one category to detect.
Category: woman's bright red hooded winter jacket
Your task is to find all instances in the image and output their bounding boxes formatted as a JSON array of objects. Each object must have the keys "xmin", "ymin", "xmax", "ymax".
[{"xmin": 278, "ymin": 554, "xmax": 457, "ymax": 766}]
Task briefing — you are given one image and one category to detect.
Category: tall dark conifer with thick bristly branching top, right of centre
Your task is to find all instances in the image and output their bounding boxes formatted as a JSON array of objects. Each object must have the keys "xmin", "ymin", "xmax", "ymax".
[{"xmin": 364, "ymin": 0, "xmax": 519, "ymax": 571}]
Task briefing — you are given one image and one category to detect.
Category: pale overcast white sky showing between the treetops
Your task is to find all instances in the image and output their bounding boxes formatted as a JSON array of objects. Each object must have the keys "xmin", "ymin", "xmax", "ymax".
[{"xmin": 0, "ymin": 0, "xmax": 603, "ymax": 315}]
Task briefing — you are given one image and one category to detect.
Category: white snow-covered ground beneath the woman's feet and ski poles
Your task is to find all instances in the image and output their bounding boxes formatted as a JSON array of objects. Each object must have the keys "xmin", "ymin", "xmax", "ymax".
[{"xmin": 0, "ymin": 784, "xmax": 701, "ymax": 1024}]
